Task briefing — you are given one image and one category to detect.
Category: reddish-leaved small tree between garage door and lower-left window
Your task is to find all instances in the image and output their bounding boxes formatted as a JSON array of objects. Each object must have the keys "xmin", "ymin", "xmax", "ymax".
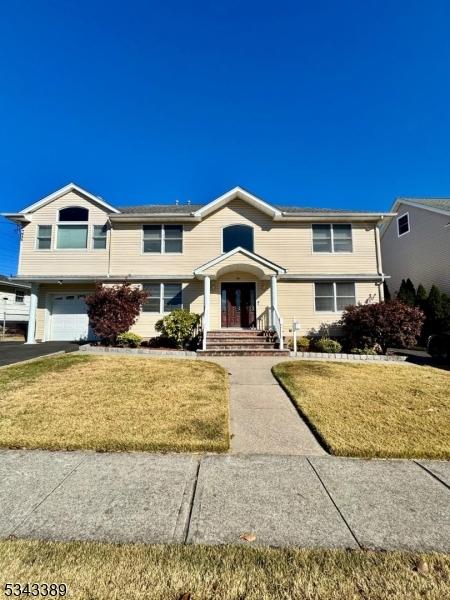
[{"xmin": 86, "ymin": 282, "xmax": 147, "ymax": 344}]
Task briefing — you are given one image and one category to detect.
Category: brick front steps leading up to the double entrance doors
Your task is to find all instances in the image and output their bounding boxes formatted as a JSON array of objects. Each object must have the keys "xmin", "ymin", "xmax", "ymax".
[{"xmin": 197, "ymin": 329, "xmax": 289, "ymax": 356}]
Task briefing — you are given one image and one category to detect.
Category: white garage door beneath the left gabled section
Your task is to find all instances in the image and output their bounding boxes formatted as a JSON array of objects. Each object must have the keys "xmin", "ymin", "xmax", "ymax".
[{"xmin": 50, "ymin": 294, "xmax": 89, "ymax": 341}]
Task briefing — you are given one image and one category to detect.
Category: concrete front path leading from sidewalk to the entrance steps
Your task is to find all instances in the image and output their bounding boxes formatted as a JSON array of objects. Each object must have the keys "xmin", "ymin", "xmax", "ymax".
[{"xmin": 206, "ymin": 356, "xmax": 326, "ymax": 456}]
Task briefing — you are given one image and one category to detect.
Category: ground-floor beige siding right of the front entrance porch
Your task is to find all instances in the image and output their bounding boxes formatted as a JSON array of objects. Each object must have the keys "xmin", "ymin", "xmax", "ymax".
[{"xmin": 278, "ymin": 281, "xmax": 379, "ymax": 336}]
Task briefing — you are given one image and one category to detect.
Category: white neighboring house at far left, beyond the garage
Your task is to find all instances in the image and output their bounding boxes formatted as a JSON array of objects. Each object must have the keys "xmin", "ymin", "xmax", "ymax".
[{"xmin": 0, "ymin": 275, "xmax": 30, "ymax": 339}]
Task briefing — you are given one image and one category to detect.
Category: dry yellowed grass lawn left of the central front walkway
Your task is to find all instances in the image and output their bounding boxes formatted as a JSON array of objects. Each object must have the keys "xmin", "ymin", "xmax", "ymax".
[{"xmin": 0, "ymin": 355, "xmax": 229, "ymax": 452}]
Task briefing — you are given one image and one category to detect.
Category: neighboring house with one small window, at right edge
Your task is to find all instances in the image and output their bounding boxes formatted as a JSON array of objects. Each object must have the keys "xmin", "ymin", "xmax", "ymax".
[{"xmin": 381, "ymin": 198, "xmax": 450, "ymax": 294}]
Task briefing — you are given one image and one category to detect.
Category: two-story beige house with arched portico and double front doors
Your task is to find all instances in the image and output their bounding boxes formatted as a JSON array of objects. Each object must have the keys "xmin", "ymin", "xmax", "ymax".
[{"xmin": 0, "ymin": 184, "xmax": 390, "ymax": 349}]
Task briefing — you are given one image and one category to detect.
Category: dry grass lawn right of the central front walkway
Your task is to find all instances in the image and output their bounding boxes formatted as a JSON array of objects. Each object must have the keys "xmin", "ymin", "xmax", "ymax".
[{"xmin": 273, "ymin": 361, "xmax": 450, "ymax": 458}]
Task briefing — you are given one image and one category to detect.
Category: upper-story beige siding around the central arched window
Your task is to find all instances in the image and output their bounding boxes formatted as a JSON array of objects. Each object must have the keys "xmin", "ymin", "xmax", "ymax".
[{"xmin": 111, "ymin": 200, "xmax": 377, "ymax": 275}]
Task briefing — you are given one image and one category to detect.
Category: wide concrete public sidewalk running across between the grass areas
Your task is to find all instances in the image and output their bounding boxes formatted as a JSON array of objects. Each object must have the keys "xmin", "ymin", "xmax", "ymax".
[{"xmin": 0, "ymin": 450, "xmax": 450, "ymax": 552}]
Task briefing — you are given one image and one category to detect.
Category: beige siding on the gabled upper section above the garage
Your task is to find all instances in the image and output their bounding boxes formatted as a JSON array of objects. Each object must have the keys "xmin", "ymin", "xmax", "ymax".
[{"xmin": 18, "ymin": 192, "xmax": 108, "ymax": 276}]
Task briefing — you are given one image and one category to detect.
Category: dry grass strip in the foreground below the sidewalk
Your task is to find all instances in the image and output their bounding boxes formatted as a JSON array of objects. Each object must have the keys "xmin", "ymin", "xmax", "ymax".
[{"xmin": 0, "ymin": 540, "xmax": 450, "ymax": 600}]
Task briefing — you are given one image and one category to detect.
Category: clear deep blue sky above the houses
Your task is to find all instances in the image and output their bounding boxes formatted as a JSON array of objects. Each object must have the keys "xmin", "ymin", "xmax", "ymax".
[{"xmin": 0, "ymin": 0, "xmax": 450, "ymax": 274}]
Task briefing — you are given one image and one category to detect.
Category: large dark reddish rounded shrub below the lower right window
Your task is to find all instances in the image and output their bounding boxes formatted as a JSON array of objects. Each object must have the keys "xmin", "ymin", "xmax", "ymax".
[{"xmin": 340, "ymin": 300, "xmax": 424, "ymax": 353}]
